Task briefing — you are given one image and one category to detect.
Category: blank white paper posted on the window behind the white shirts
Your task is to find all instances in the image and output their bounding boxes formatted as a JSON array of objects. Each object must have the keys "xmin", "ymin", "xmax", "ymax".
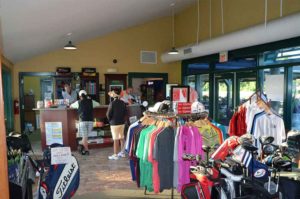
[{"xmin": 265, "ymin": 75, "xmax": 284, "ymax": 102}]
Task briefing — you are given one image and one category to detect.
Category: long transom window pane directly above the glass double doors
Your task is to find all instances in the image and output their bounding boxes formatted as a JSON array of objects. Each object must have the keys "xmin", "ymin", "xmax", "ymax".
[{"xmin": 216, "ymin": 58, "xmax": 256, "ymax": 70}]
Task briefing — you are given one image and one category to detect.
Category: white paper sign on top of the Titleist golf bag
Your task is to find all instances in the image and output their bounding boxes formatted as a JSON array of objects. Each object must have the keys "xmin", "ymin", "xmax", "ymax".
[{"xmin": 51, "ymin": 147, "xmax": 72, "ymax": 165}]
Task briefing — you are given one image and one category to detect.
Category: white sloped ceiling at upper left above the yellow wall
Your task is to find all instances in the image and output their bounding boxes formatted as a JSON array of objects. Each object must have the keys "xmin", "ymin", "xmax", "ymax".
[{"xmin": 0, "ymin": 0, "xmax": 195, "ymax": 62}]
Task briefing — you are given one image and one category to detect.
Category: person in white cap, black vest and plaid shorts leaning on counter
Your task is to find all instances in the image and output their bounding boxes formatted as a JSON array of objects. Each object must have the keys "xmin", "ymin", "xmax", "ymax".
[{"xmin": 70, "ymin": 90, "xmax": 100, "ymax": 155}]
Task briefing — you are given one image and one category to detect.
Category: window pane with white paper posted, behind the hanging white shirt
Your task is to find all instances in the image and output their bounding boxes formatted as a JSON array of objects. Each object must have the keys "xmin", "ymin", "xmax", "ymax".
[{"xmin": 263, "ymin": 67, "xmax": 284, "ymax": 116}]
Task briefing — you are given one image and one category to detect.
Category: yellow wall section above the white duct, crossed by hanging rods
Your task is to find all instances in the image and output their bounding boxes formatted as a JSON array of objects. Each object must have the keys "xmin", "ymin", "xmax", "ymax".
[{"xmin": 175, "ymin": 0, "xmax": 300, "ymax": 47}]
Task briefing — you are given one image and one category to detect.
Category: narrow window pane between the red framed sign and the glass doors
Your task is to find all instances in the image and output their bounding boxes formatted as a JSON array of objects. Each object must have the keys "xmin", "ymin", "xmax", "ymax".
[{"xmin": 196, "ymin": 74, "xmax": 209, "ymax": 111}]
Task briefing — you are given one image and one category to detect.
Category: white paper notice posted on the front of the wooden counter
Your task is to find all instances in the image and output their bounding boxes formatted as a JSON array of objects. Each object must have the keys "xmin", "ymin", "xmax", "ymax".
[{"xmin": 45, "ymin": 122, "xmax": 63, "ymax": 146}]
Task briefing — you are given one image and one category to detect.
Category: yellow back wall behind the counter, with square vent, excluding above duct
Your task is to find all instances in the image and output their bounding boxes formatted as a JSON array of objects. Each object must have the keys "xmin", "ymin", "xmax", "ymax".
[{"xmin": 14, "ymin": 17, "xmax": 181, "ymax": 130}]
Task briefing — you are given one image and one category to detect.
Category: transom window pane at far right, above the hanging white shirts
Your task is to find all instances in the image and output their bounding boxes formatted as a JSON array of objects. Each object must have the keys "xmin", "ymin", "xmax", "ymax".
[{"xmin": 259, "ymin": 46, "xmax": 300, "ymax": 66}]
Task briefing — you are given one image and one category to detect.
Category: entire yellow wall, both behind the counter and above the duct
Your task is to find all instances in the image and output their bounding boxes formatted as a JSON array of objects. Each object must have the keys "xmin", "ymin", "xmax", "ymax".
[{"xmin": 14, "ymin": 0, "xmax": 300, "ymax": 132}]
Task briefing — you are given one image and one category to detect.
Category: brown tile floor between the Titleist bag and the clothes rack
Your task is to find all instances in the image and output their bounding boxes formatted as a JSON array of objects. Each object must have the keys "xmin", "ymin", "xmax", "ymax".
[{"xmin": 32, "ymin": 142, "xmax": 180, "ymax": 199}]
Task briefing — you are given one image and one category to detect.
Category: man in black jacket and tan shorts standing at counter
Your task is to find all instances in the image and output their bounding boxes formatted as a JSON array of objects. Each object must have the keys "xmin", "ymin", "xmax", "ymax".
[{"xmin": 106, "ymin": 90, "xmax": 127, "ymax": 160}]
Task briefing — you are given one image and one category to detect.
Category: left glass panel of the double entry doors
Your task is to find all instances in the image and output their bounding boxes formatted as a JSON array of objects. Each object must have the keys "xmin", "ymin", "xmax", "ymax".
[{"xmin": 215, "ymin": 73, "xmax": 234, "ymax": 126}]
